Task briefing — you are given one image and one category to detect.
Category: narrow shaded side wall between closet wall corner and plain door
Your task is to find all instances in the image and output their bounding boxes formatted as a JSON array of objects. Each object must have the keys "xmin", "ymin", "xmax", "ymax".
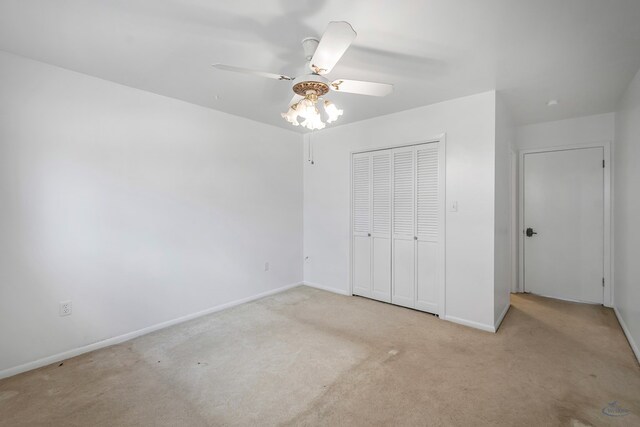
[{"xmin": 493, "ymin": 93, "xmax": 515, "ymax": 328}]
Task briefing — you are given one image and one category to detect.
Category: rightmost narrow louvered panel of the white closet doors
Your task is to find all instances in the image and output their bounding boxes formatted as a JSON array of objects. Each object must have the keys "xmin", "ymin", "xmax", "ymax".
[{"xmin": 415, "ymin": 142, "xmax": 440, "ymax": 314}]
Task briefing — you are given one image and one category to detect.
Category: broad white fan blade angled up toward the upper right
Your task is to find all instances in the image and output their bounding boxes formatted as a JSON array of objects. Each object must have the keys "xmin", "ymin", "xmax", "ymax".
[{"xmin": 309, "ymin": 21, "xmax": 356, "ymax": 74}]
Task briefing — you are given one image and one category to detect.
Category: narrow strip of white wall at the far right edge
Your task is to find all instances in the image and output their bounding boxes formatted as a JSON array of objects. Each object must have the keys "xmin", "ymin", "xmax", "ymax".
[{"xmin": 613, "ymin": 66, "xmax": 640, "ymax": 360}]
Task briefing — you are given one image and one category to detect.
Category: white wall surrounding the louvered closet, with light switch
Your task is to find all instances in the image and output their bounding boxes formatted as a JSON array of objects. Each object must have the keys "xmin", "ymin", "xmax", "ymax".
[{"xmin": 304, "ymin": 92, "xmax": 496, "ymax": 329}]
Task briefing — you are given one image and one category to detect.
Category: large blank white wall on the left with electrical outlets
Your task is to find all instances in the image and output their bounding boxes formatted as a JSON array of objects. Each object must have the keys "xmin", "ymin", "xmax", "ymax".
[{"xmin": 0, "ymin": 53, "xmax": 303, "ymax": 374}]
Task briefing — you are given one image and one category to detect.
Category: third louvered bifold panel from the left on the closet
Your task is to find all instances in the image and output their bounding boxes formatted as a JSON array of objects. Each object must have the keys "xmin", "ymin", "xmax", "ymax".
[{"xmin": 391, "ymin": 147, "xmax": 416, "ymax": 308}]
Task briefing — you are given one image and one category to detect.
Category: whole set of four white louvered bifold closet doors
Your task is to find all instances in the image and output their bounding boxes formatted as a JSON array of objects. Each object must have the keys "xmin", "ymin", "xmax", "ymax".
[{"xmin": 351, "ymin": 142, "xmax": 444, "ymax": 314}]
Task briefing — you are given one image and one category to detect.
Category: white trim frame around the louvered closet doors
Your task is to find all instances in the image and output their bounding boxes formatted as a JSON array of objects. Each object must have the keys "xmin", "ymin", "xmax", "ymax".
[{"xmin": 349, "ymin": 133, "xmax": 447, "ymax": 319}]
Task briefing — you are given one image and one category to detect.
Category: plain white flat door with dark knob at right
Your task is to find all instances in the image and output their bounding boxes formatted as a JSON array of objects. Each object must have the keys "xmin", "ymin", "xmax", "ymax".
[{"xmin": 523, "ymin": 148, "xmax": 604, "ymax": 304}]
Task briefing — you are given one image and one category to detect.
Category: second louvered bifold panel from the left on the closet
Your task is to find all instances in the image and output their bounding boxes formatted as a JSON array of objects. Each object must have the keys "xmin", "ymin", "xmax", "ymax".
[{"xmin": 371, "ymin": 150, "xmax": 391, "ymax": 302}]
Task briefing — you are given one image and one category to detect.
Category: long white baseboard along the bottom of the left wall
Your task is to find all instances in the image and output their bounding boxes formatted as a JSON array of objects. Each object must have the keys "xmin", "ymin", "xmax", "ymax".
[{"xmin": 0, "ymin": 282, "xmax": 303, "ymax": 379}]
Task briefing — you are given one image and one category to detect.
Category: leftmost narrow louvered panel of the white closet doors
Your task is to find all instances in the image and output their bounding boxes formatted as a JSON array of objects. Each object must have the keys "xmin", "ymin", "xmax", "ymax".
[{"xmin": 352, "ymin": 153, "xmax": 372, "ymax": 297}]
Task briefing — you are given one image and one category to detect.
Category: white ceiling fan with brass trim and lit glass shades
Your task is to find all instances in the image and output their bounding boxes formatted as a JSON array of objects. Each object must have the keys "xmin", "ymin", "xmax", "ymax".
[{"xmin": 213, "ymin": 21, "xmax": 393, "ymax": 130}]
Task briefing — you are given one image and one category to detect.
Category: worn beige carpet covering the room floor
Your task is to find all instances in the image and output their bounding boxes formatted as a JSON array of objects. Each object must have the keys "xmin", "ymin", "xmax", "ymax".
[{"xmin": 0, "ymin": 287, "xmax": 640, "ymax": 426}]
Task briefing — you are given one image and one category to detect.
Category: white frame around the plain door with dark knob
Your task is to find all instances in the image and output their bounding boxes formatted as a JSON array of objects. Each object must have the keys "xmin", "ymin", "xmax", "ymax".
[{"xmin": 515, "ymin": 141, "xmax": 613, "ymax": 307}]
